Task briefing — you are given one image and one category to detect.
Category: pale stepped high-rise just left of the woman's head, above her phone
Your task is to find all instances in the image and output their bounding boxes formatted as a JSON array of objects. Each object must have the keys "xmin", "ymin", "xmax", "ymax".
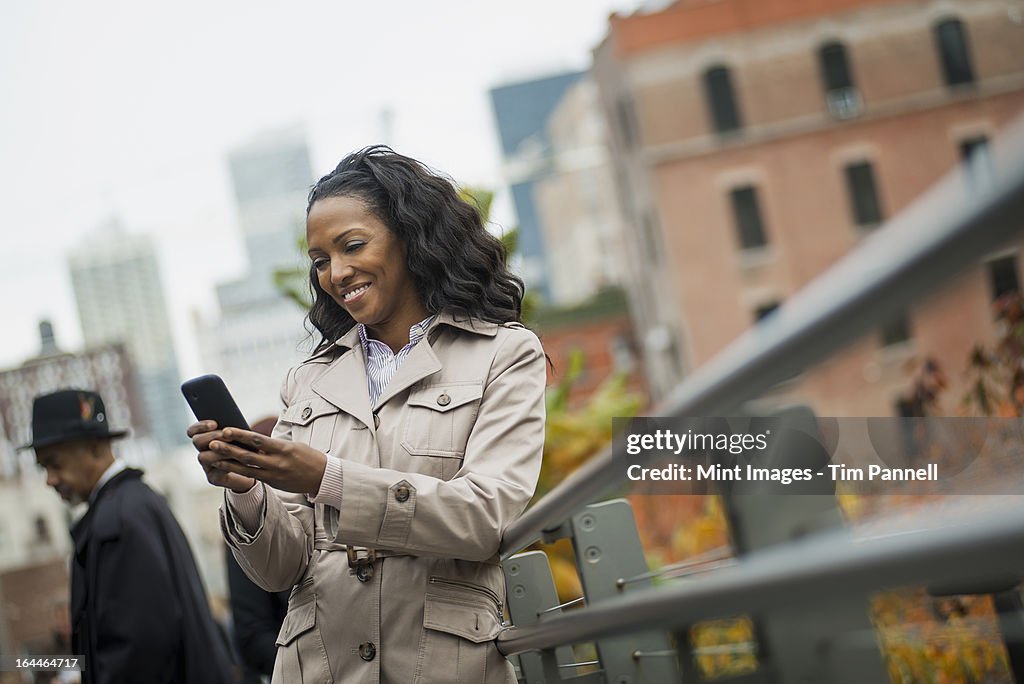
[{"xmin": 197, "ymin": 127, "xmax": 315, "ymax": 422}]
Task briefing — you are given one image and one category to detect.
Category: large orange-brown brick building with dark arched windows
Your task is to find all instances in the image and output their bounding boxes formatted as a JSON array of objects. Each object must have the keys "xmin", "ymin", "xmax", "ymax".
[{"xmin": 593, "ymin": 0, "xmax": 1024, "ymax": 415}]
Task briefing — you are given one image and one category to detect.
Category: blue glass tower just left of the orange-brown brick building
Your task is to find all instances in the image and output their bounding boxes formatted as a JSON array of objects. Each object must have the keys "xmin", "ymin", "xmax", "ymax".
[{"xmin": 490, "ymin": 72, "xmax": 584, "ymax": 303}]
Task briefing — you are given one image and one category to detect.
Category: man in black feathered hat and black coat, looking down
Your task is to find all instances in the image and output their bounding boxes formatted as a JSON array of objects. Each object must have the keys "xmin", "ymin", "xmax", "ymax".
[{"xmin": 22, "ymin": 389, "xmax": 234, "ymax": 684}]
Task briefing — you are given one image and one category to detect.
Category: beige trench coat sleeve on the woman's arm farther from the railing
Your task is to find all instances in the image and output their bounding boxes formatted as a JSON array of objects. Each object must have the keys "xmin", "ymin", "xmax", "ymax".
[{"xmin": 220, "ymin": 362, "xmax": 313, "ymax": 592}]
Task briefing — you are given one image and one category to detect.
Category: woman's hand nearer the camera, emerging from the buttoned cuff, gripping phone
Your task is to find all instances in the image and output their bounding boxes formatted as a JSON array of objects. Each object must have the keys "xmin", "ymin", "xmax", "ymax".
[{"xmin": 193, "ymin": 428, "xmax": 327, "ymax": 495}]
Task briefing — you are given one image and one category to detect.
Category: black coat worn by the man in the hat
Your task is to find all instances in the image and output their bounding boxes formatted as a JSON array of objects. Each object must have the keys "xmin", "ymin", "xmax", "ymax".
[{"xmin": 71, "ymin": 468, "xmax": 233, "ymax": 684}]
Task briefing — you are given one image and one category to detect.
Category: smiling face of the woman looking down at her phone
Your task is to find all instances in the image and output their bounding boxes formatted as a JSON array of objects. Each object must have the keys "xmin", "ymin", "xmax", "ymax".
[{"xmin": 306, "ymin": 197, "xmax": 427, "ymax": 339}]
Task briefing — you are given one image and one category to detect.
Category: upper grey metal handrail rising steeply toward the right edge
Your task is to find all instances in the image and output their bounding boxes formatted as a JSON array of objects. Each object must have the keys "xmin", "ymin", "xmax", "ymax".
[{"xmin": 501, "ymin": 113, "xmax": 1024, "ymax": 560}]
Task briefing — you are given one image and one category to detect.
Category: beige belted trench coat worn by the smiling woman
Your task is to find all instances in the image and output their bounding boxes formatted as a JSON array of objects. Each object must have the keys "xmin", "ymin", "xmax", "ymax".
[{"xmin": 221, "ymin": 313, "xmax": 546, "ymax": 684}]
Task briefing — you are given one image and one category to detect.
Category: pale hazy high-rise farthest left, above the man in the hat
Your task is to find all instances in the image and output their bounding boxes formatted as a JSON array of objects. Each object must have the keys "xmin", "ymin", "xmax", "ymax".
[{"xmin": 69, "ymin": 220, "xmax": 187, "ymax": 450}]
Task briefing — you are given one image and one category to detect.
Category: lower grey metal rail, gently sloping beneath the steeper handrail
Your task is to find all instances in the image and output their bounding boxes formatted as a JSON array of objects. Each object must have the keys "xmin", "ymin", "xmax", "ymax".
[{"xmin": 498, "ymin": 497, "xmax": 1024, "ymax": 655}]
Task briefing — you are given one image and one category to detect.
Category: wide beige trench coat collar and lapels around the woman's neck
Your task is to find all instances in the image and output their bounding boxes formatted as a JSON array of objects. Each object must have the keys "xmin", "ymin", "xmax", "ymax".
[{"xmin": 311, "ymin": 312, "xmax": 498, "ymax": 427}]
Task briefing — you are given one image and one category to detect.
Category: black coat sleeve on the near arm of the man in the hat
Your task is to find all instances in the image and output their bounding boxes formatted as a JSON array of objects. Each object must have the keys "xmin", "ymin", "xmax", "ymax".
[{"xmin": 90, "ymin": 499, "xmax": 182, "ymax": 684}]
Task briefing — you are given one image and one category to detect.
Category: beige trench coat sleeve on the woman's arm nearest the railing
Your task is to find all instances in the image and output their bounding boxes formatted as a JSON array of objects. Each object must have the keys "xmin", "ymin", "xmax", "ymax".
[{"xmin": 317, "ymin": 328, "xmax": 547, "ymax": 561}]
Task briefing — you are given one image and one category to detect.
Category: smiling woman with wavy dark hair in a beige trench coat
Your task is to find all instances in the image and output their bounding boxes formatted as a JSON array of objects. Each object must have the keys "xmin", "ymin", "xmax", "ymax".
[{"xmin": 188, "ymin": 146, "xmax": 546, "ymax": 684}]
